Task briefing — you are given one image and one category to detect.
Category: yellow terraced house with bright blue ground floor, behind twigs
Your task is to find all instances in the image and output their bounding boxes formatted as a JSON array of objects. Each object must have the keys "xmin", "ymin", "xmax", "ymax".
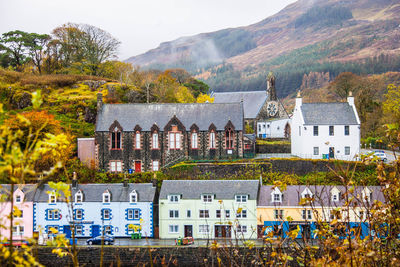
[{"xmin": 257, "ymin": 185, "xmax": 384, "ymax": 238}]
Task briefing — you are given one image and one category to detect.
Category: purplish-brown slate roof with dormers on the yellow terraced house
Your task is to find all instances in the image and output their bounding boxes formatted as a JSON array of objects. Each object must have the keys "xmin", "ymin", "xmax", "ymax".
[{"xmin": 257, "ymin": 185, "xmax": 385, "ymax": 207}]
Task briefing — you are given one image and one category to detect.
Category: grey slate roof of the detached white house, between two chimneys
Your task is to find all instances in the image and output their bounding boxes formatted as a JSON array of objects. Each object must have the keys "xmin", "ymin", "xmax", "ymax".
[{"xmin": 301, "ymin": 103, "xmax": 358, "ymax": 125}]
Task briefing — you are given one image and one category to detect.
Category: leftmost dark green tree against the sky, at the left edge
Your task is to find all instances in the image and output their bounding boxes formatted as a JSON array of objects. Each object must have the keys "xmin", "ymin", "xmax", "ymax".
[{"xmin": 0, "ymin": 30, "xmax": 29, "ymax": 71}]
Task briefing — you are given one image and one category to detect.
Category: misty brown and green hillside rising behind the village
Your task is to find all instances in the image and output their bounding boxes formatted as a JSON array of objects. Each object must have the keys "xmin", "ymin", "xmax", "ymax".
[{"xmin": 127, "ymin": 0, "xmax": 400, "ymax": 97}]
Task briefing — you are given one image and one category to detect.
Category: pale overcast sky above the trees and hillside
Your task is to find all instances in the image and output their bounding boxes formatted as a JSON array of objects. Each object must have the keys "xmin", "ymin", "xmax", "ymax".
[{"xmin": 0, "ymin": 0, "xmax": 295, "ymax": 60}]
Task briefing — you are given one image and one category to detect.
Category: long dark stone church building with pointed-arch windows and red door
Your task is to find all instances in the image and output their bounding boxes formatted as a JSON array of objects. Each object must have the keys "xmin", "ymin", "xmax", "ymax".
[{"xmin": 94, "ymin": 93, "xmax": 244, "ymax": 172}]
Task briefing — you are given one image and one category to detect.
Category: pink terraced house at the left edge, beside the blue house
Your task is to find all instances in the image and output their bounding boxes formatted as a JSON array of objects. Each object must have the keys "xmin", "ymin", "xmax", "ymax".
[{"xmin": 0, "ymin": 184, "xmax": 35, "ymax": 241}]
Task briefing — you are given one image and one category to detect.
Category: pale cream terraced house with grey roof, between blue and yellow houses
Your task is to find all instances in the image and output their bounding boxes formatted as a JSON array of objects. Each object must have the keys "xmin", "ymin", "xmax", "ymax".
[{"xmin": 159, "ymin": 180, "xmax": 259, "ymax": 239}]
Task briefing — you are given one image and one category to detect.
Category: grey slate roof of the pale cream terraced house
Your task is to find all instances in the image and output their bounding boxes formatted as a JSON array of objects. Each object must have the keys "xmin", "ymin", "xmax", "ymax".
[{"xmin": 160, "ymin": 180, "xmax": 259, "ymax": 200}]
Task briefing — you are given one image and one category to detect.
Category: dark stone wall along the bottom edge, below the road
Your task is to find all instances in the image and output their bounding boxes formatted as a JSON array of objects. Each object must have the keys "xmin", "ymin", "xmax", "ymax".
[{"xmin": 35, "ymin": 246, "xmax": 298, "ymax": 267}]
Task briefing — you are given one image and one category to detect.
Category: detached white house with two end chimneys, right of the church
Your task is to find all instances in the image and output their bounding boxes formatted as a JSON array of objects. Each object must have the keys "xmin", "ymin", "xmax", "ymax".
[{"xmin": 291, "ymin": 93, "xmax": 360, "ymax": 160}]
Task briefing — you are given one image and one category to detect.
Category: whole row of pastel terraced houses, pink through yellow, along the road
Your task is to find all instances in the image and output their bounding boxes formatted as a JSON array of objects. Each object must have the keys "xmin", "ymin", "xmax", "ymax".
[{"xmin": 0, "ymin": 180, "xmax": 385, "ymax": 240}]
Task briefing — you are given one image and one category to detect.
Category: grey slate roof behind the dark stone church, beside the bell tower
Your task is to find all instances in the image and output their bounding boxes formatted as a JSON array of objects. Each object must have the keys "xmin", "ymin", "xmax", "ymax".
[{"xmin": 212, "ymin": 91, "xmax": 268, "ymax": 119}]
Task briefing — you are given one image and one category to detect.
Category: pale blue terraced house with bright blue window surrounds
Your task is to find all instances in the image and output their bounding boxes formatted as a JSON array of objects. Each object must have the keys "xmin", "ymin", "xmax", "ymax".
[{"xmin": 33, "ymin": 183, "xmax": 156, "ymax": 238}]
